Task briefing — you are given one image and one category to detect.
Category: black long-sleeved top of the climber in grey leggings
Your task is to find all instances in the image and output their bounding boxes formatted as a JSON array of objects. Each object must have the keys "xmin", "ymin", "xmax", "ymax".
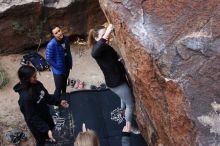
[{"xmin": 91, "ymin": 38, "xmax": 127, "ymax": 88}]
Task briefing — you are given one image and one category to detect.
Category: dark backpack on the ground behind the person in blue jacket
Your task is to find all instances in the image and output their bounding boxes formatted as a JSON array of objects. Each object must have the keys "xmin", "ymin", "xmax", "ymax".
[{"xmin": 20, "ymin": 52, "xmax": 50, "ymax": 71}]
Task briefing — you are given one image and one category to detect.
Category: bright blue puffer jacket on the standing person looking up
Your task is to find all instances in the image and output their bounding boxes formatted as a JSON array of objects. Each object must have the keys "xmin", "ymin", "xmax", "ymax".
[{"xmin": 46, "ymin": 36, "xmax": 72, "ymax": 75}]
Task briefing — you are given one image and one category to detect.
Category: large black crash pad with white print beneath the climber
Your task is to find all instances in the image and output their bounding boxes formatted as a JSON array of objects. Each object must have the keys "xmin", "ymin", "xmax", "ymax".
[{"xmin": 48, "ymin": 89, "xmax": 147, "ymax": 146}]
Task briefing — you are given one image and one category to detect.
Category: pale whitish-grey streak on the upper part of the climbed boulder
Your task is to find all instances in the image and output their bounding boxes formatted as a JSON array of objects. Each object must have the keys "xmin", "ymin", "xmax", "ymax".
[{"xmin": 112, "ymin": 0, "xmax": 166, "ymax": 57}]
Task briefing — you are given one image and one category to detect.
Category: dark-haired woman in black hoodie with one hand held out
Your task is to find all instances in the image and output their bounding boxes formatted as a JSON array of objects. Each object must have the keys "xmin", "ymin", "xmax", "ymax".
[{"xmin": 14, "ymin": 66, "xmax": 69, "ymax": 146}]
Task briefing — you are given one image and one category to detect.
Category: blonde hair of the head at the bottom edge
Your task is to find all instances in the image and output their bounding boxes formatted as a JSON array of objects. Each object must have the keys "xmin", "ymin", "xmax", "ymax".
[{"xmin": 74, "ymin": 130, "xmax": 100, "ymax": 146}]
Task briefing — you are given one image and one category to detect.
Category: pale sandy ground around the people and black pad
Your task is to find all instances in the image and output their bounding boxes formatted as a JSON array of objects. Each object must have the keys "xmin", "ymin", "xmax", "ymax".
[{"xmin": 0, "ymin": 44, "xmax": 104, "ymax": 146}]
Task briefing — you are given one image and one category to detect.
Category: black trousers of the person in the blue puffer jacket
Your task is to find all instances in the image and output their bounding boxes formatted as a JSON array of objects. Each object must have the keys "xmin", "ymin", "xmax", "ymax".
[{"xmin": 53, "ymin": 71, "xmax": 69, "ymax": 98}]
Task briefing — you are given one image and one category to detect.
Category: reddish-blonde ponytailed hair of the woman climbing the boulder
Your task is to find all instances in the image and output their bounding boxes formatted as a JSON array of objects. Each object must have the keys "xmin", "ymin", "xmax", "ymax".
[{"xmin": 87, "ymin": 25, "xmax": 105, "ymax": 48}]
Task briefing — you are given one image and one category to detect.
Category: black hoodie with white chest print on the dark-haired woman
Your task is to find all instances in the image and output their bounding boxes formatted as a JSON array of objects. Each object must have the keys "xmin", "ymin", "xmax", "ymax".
[{"xmin": 14, "ymin": 81, "xmax": 61, "ymax": 142}]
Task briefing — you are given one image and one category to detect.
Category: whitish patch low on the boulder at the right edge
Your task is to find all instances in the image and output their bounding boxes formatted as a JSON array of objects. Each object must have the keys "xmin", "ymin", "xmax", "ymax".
[{"xmin": 198, "ymin": 101, "xmax": 220, "ymax": 135}]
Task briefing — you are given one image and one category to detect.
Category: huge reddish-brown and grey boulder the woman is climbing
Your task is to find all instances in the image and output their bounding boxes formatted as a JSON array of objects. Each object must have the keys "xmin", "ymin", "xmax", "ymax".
[{"xmin": 100, "ymin": 0, "xmax": 220, "ymax": 146}]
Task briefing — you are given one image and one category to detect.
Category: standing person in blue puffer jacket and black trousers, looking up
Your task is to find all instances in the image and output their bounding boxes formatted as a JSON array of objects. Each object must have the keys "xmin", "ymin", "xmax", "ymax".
[{"xmin": 46, "ymin": 26, "xmax": 72, "ymax": 98}]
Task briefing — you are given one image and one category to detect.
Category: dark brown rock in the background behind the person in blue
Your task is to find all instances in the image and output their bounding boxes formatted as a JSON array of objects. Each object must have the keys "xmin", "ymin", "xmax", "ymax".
[{"xmin": 0, "ymin": 0, "xmax": 106, "ymax": 54}]
